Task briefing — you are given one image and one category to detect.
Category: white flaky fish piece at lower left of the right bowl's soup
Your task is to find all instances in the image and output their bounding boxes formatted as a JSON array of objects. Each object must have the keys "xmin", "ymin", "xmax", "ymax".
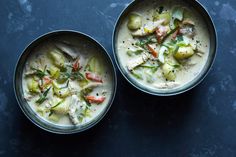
[{"xmin": 127, "ymin": 52, "xmax": 150, "ymax": 70}]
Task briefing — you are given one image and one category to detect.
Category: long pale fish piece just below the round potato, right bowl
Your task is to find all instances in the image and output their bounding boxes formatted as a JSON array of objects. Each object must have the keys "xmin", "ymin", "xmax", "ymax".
[{"xmin": 131, "ymin": 19, "xmax": 165, "ymax": 37}]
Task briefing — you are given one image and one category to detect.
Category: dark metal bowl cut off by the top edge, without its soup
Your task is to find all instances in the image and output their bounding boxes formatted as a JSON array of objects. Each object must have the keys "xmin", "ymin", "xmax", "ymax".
[{"xmin": 112, "ymin": 0, "xmax": 217, "ymax": 96}]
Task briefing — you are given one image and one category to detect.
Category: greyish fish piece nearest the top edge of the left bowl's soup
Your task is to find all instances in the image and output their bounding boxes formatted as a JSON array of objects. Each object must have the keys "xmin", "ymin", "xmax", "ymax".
[{"xmin": 55, "ymin": 41, "xmax": 79, "ymax": 59}]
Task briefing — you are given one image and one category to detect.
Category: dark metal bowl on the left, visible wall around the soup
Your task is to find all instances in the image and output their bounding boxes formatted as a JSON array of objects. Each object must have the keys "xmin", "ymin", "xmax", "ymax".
[{"xmin": 13, "ymin": 30, "xmax": 117, "ymax": 134}]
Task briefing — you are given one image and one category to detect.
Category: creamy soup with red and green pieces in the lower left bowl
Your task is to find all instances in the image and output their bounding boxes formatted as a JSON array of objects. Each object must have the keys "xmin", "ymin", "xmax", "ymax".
[{"xmin": 22, "ymin": 39, "xmax": 113, "ymax": 125}]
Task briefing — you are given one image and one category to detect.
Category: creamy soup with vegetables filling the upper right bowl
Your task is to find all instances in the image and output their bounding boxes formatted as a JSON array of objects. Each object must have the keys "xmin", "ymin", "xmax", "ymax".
[{"xmin": 115, "ymin": 1, "xmax": 210, "ymax": 90}]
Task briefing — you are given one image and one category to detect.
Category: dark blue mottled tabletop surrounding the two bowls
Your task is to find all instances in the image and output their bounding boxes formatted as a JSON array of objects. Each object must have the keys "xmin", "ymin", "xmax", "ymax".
[{"xmin": 0, "ymin": 0, "xmax": 236, "ymax": 157}]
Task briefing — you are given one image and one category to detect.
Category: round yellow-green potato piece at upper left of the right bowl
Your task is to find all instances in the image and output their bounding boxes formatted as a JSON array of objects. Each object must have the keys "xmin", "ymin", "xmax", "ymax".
[{"xmin": 127, "ymin": 13, "xmax": 142, "ymax": 30}]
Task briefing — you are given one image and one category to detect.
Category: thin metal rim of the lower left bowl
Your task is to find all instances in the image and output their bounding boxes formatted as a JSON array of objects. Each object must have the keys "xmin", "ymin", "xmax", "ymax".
[{"xmin": 13, "ymin": 29, "xmax": 117, "ymax": 134}]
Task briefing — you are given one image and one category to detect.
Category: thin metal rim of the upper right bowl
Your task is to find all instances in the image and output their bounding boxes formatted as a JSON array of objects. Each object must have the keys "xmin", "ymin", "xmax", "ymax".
[{"xmin": 112, "ymin": 0, "xmax": 218, "ymax": 97}]
